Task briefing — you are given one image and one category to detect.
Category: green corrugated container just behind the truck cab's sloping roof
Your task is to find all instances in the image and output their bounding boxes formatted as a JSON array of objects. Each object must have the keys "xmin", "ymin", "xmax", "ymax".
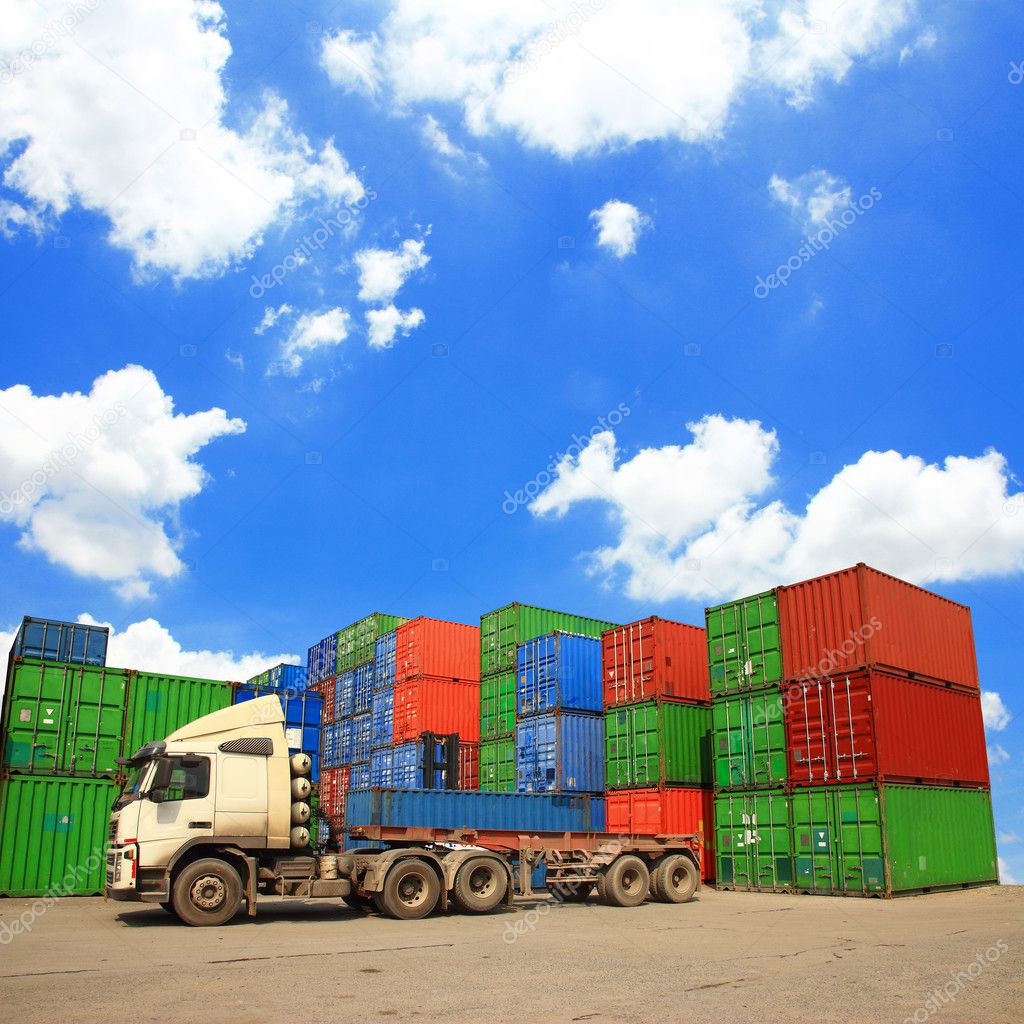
[{"xmin": 125, "ymin": 672, "xmax": 233, "ymax": 755}]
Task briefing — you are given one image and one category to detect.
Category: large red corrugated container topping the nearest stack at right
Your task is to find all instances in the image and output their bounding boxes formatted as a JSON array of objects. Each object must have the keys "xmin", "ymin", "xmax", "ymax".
[{"xmin": 778, "ymin": 563, "xmax": 979, "ymax": 690}]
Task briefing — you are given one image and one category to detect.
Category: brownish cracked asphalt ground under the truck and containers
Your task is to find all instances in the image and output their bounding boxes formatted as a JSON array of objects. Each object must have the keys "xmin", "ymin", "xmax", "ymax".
[{"xmin": 0, "ymin": 887, "xmax": 1024, "ymax": 1024}]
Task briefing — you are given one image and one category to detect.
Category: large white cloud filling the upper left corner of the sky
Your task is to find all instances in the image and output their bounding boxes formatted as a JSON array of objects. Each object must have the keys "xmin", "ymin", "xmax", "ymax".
[{"xmin": 0, "ymin": 0, "xmax": 364, "ymax": 280}]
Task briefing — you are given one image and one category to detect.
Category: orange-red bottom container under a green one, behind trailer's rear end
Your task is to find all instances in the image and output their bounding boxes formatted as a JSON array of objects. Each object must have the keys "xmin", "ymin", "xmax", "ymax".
[{"xmin": 605, "ymin": 785, "xmax": 715, "ymax": 882}]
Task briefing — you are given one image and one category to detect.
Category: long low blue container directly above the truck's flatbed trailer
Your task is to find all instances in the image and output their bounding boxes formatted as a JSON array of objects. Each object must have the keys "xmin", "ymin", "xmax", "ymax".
[{"xmin": 345, "ymin": 790, "xmax": 605, "ymax": 833}]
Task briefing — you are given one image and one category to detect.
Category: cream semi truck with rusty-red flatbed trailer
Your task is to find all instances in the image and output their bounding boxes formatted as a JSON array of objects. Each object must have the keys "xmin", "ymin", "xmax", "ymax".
[{"xmin": 105, "ymin": 696, "xmax": 701, "ymax": 927}]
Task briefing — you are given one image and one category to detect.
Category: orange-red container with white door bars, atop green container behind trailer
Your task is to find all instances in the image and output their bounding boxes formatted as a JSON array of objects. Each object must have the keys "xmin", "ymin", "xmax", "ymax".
[{"xmin": 601, "ymin": 615, "xmax": 711, "ymax": 708}]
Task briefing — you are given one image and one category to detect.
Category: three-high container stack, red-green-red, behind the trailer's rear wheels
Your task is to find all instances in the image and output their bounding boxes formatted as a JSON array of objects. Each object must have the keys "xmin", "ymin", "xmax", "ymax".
[{"xmin": 601, "ymin": 617, "xmax": 715, "ymax": 881}]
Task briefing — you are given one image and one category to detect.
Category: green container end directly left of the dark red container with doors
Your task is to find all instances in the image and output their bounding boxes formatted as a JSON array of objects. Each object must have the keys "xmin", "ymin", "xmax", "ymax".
[{"xmin": 711, "ymin": 686, "xmax": 786, "ymax": 790}]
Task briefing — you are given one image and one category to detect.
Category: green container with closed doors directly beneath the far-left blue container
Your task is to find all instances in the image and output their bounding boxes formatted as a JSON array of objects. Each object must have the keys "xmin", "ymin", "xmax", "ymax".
[{"xmin": 3, "ymin": 660, "xmax": 128, "ymax": 777}]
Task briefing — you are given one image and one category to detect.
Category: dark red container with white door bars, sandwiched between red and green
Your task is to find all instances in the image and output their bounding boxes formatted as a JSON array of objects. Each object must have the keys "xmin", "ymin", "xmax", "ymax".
[{"xmin": 782, "ymin": 669, "xmax": 988, "ymax": 786}]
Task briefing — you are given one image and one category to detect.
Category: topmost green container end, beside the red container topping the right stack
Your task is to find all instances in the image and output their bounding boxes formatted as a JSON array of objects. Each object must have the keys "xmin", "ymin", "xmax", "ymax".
[{"xmin": 706, "ymin": 591, "xmax": 782, "ymax": 694}]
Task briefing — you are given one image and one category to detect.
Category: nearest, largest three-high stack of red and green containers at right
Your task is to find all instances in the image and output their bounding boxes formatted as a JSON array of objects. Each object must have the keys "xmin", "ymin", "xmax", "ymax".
[{"xmin": 708, "ymin": 565, "xmax": 997, "ymax": 895}]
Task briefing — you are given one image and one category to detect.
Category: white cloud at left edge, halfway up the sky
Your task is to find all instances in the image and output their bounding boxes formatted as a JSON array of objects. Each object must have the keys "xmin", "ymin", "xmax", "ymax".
[{"xmin": 0, "ymin": 366, "xmax": 246, "ymax": 597}]
